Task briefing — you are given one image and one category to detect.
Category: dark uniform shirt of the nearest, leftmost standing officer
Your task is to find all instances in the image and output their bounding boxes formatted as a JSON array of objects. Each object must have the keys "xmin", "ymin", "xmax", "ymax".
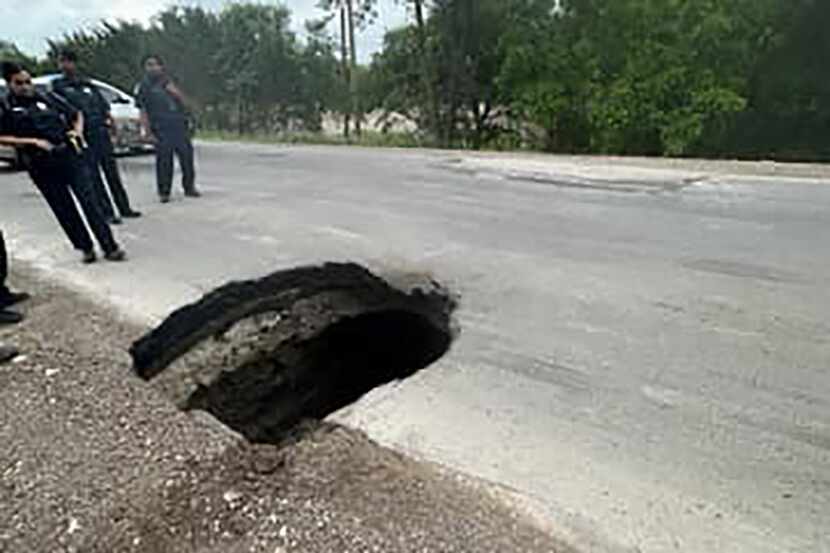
[{"xmin": 0, "ymin": 93, "xmax": 78, "ymax": 161}]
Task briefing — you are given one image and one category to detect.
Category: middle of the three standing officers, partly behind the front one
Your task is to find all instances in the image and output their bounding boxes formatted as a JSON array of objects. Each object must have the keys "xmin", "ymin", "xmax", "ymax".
[{"xmin": 52, "ymin": 50, "xmax": 141, "ymax": 224}]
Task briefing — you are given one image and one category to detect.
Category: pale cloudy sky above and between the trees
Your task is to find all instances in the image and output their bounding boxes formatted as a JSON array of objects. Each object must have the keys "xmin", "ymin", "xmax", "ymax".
[{"xmin": 0, "ymin": 0, "xmax": 406, "ymax": 62}]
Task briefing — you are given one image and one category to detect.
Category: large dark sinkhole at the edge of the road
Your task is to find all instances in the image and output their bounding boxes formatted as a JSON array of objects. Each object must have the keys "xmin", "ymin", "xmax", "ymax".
[{"xmin": 130, "ymin": 264, "xmax": 456, "ymax": 443}]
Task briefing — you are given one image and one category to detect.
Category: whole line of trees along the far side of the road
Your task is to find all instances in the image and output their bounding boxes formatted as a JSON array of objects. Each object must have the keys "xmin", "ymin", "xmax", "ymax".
[{"xmin": 0, "ymin": 0, "xmax": 830, "ymax": 159}]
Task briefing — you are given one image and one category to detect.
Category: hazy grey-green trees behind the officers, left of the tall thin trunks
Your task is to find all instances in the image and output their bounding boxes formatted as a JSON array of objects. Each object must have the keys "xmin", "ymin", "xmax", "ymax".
[{"xmin": 50, "ymin": 3, "xmax": 337, "ymax": 133}]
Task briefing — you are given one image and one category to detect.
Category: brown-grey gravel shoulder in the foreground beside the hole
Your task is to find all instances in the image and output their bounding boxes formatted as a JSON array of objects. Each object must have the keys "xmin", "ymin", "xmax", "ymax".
[{"xmin": 0, "ymin": 265, "xmax": 567, "ymax": 553}]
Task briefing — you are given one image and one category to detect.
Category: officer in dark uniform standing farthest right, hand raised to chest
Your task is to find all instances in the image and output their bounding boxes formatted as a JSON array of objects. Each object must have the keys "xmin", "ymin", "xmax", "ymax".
[{"xmin": 136, "ymin": 55, "xmax": 201, "ymax": 203}]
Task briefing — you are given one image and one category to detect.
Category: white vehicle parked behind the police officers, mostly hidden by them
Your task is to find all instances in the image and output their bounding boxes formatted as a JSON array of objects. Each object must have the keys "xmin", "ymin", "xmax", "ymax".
[{"xmin": 0, "ymin": 74, "xmax": 152, "ymax": 166}]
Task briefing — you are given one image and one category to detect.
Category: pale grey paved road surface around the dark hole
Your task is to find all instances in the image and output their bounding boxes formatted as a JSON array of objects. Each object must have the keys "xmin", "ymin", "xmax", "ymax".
[{"xmin": 0, "ymin": 144, "xmax": 830, "ymax": 553}]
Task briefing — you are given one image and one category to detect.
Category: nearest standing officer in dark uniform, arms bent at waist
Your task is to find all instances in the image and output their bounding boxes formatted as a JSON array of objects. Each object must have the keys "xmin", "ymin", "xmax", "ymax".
[{"xmin": 0, "ymin": 63, "xmax": 126, "ymax": 263}]
